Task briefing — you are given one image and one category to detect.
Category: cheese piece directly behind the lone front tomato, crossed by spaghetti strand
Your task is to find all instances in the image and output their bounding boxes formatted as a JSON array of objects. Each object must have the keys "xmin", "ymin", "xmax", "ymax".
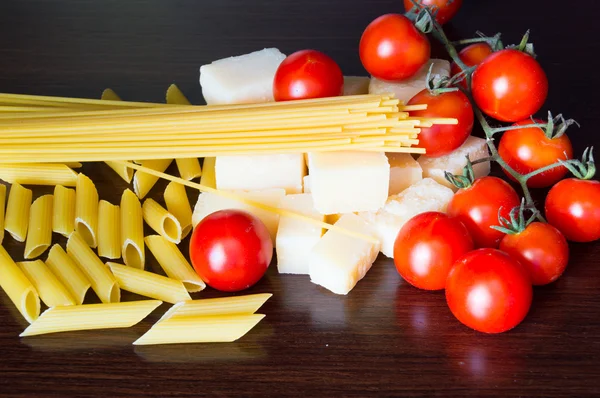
[{"xmin": 192, "ymin": 188, "xmax": 285, "ymax": 243}]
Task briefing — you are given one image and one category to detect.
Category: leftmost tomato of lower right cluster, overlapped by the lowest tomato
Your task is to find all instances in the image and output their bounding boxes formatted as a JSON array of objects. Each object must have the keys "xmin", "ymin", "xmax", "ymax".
[{"xmin": 394, "ymin": 212, "xmax": 473, "ymax": 290}]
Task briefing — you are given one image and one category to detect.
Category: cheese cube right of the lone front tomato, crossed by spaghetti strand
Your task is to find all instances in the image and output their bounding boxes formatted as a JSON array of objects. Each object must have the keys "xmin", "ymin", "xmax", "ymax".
[{"xmin": 275, "ymin": 193, "xmax": 325, "ymax": 275}]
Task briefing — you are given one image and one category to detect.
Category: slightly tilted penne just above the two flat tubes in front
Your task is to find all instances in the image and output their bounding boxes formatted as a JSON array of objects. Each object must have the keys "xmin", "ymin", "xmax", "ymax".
[{"xmin": 106, "ymin": 262, "xmax": 192, "ymax": 304}]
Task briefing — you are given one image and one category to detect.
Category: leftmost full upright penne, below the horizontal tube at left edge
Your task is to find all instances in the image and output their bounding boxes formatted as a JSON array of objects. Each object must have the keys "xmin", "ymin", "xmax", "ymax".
[{"xmin": 4, "ymin": 183, "xmax": 33, "ymax": 242}]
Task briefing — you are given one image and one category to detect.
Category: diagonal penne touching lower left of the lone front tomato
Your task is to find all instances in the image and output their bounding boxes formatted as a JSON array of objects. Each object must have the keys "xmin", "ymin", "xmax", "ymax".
[{"xmin": 144, "ymin": 235, "xmax": 206, "ymax": 293}]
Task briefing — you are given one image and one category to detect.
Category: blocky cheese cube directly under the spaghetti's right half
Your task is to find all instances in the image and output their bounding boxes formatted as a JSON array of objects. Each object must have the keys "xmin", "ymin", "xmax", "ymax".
[{"xmin": 308, "ymin": 151, "xmax": 390, "ymax": 214}]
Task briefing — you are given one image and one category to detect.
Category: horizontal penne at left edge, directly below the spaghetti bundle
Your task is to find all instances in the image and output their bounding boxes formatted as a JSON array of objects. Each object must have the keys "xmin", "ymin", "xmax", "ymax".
[{"xmin": 0, "ymin": 163, "xmax": 77, "ymax": 187}]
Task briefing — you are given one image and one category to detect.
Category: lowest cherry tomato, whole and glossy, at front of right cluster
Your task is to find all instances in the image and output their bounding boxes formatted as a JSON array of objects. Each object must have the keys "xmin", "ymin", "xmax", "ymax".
[{"xmin": 446, "ymin": 249, "xmax": 533, "ymax": 333}]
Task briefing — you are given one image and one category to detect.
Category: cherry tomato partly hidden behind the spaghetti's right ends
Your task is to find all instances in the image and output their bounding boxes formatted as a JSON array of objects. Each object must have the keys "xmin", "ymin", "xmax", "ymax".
[{"xmin": 408, "ymin": 89, "xmax": 474, "ymax": 158}]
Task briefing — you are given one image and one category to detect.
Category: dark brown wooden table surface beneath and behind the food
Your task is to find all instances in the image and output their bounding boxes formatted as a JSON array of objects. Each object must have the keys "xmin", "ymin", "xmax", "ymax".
[{"xmin": 0, "ymin": 0, "xmax": 600, "ymax": 397}]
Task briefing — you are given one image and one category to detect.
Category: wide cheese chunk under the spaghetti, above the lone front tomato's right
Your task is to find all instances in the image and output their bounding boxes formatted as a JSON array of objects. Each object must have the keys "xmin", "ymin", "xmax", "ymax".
[{"xmin": 215, "ymin": 153, "xmax": 306, "ymax": 194}]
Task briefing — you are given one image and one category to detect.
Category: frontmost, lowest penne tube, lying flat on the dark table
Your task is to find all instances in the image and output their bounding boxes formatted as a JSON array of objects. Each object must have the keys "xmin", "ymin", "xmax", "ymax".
[{"xmin": 133, "ymin": 314, "xmax": 265, "ymax": 345}]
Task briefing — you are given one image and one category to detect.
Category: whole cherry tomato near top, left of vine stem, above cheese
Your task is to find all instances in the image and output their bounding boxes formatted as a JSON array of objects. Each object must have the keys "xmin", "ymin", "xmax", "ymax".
[{"xmin": 359, "ymin": 14, "xmax": 431, "ymax": 80}]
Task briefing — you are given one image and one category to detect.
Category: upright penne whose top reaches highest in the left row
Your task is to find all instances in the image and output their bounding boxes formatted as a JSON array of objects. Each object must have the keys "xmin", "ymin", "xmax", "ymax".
[{"xmin": 75, "ymin": 173, "xmax": 98, "ymax": 248}]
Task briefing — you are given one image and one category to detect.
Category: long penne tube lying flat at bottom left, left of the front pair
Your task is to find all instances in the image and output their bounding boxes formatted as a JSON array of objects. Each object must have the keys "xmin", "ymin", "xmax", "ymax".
[{"xmin": 20, "ymin": 300, "xmax": 162, "ymax": 337}]
